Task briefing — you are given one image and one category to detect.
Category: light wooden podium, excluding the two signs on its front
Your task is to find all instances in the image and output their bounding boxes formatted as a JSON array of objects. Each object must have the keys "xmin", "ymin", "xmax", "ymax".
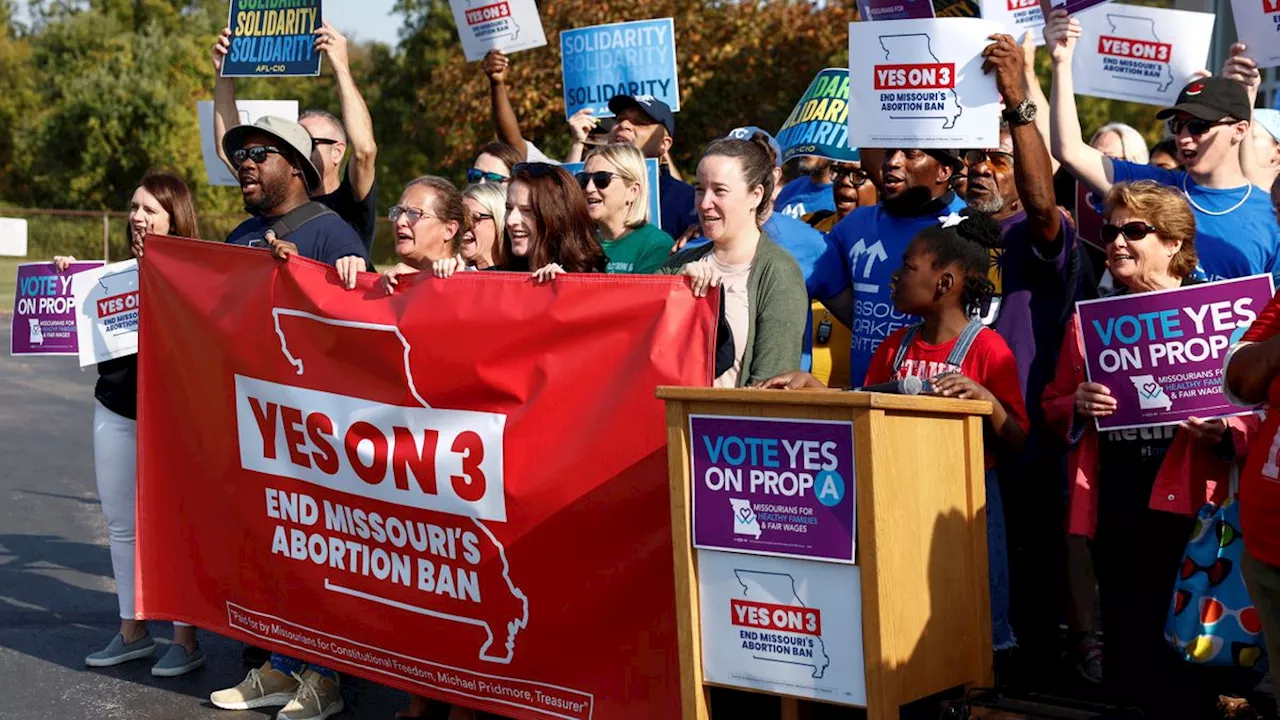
[{"xmin": 658, "ymin": 387, "xmax": 993, "ymax": 720}]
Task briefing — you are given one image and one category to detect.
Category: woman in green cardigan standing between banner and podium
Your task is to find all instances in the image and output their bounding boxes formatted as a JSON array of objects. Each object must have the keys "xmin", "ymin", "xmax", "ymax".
[{"xmin": 658, "ymin": 133, "xmax": 809, "ymax": 387}]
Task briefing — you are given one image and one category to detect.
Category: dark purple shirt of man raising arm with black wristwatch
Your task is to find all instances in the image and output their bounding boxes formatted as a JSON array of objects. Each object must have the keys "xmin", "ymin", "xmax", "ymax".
[{"xmin": 982, "ymin": 210, "xmax": 1079, "ymax": 435}]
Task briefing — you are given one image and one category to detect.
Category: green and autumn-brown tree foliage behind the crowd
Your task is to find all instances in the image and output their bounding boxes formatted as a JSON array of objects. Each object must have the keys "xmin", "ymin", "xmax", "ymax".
[{"xmin": 0, "ymin": 0, "xmax": 1164, "ymax": 257}]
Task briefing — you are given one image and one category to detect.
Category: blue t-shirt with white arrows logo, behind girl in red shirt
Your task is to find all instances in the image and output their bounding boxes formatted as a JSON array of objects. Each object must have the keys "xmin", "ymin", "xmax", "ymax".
[{"xmin": 809, "ymin": 192, "xmax": 965, "ymax": 384}]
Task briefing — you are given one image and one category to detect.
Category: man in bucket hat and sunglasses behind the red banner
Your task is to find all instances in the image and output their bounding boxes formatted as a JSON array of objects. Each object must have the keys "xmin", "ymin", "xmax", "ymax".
[{"xmin": 223, "ymin": 117, "xmax": 369, "ymax": 270}]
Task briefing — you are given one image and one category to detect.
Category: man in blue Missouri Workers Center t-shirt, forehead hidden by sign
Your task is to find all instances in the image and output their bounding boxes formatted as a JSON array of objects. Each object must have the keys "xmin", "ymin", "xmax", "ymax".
[{"xmin": 809, "ymin": 149, "xmax": 965, "ymax": 386}]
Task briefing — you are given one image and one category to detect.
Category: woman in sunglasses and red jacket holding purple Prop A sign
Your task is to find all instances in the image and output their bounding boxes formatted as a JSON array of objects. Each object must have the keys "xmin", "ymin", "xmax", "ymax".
[{"xmin": 1042, "ymin": 181, "xmax": 1248, "ymax": 717}]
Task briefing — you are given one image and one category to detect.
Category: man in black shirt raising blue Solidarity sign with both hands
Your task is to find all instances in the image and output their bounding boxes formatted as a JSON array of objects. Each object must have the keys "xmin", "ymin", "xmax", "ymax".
[{"xmin": 212, "ymin": 22, "xmax": 378, "ymax": 251}]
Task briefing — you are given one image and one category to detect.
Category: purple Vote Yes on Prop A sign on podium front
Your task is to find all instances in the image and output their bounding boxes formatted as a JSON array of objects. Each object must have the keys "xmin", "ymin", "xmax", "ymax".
[{"xmin": 689, "ymin": 415, "xmax": 856, "ymax": 562}]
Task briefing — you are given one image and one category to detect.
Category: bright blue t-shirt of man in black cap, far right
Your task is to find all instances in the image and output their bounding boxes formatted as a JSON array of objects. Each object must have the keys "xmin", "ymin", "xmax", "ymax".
[{"xmin": 1112, "ymin": 160, "xmax": 1280, "ymax": 281}]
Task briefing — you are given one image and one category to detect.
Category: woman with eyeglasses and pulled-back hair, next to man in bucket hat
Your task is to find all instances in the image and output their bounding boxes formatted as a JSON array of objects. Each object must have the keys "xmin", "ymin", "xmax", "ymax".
[{"xmin": 383, "ymin": 176, "xmax": 470, "ymax": 295}]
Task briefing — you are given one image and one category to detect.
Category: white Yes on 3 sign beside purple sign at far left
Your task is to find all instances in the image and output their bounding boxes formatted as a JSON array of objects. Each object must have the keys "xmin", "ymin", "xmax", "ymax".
[{"xmin": 72, "ymin": 257, "xmax": 140, "ymax": 368}]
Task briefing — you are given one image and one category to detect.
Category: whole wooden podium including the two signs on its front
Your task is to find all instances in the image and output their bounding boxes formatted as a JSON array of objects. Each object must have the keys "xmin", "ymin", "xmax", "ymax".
[{"xmin": 658, "ymin": 387, "xmax": 993, "ymax": 720}]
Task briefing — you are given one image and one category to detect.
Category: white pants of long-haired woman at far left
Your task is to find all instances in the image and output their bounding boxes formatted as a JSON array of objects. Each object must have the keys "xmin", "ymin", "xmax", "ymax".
[{"xmin": 93, "ymin": 401, "xmax": 184, "ymax": 625}]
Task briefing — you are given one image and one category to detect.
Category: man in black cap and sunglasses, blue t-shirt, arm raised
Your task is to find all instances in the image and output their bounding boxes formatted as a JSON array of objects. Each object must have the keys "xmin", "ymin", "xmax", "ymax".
[{"xmin": 1044, "ymin": 10, "xmax": 1280, "ymax": 279}]
